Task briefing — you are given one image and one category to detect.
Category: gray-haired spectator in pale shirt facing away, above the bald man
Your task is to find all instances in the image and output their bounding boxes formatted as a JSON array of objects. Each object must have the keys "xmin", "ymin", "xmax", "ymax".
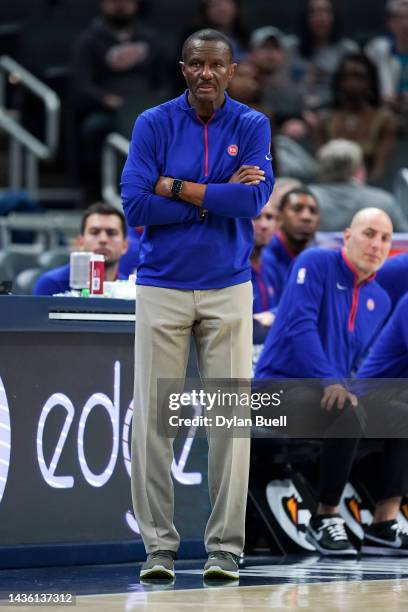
[{"xmin": 309, "ymin": 139, "xmax": 408, "ymax": 232}]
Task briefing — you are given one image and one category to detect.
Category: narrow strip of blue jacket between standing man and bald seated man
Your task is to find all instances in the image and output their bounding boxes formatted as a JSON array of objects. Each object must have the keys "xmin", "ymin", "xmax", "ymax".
[{"xmin": 262, "ymin": 232, "xmax": 295, "ymax": 306}]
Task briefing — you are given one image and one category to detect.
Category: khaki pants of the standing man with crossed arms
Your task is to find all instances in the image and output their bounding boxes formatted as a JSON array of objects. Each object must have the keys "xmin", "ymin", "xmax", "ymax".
[{"xmin": 131, "ymin": 282, "xmax": 253, "ymax": 555}]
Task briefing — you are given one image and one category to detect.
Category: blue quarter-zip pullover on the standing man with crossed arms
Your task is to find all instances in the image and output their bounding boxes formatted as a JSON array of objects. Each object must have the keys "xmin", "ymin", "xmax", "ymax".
[{"xmin": 122, "ymin": 92, "xmax": 273, "ymax": 289}]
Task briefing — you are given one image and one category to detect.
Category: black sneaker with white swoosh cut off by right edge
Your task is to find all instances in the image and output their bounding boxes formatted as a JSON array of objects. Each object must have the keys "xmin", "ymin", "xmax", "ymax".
[{"xmin": 360, "ymin": 520, "xmax": 408, "ymax": 556}]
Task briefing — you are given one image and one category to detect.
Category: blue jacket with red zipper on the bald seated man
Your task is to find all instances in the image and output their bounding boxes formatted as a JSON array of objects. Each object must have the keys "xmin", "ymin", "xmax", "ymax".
[{"xmin": 255, "ymin": 248, "xmax": 390, "ymax": 380}]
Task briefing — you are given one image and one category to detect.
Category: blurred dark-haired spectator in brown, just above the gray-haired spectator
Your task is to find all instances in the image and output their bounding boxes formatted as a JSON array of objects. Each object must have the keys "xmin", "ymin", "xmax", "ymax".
[{"xmin": 309, "ymin": 53, "xmax": 397, "ymax": 180}]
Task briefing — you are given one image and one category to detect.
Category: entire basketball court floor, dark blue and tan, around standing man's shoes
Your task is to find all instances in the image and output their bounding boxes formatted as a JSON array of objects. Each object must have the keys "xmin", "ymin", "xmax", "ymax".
[{"xmin": 0, "ymin": 555, "xmax": 408, "ymax": 612}]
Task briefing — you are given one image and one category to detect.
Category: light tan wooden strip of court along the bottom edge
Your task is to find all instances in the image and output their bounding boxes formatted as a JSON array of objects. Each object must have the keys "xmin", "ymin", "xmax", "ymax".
[{"xmin": 6, "ymin": 580, "xmax": 408, "ymax": 612}]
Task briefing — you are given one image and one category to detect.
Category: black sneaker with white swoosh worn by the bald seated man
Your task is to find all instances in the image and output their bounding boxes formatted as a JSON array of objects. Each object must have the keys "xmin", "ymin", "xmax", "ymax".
[{"xmin": 306, "ymin": 514, "xmax": 357, "ymax": 556}]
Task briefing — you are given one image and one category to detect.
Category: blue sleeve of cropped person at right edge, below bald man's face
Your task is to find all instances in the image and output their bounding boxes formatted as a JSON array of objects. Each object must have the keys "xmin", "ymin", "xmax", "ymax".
[{"xmin": 357, "ymin": 294, "xmax": 408, "ymax": 378}]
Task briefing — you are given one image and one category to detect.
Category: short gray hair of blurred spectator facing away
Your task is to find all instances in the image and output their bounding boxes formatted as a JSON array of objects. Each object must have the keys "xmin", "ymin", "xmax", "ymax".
[{"xmin": 317, "ymin": 138, "xmax": 364, "ymax": 183}]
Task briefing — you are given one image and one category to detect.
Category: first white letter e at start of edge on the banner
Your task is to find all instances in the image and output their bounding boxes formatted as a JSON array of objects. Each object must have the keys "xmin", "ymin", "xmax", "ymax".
[{"xmin": 37, "ymin": 393, "xmax": 75, "ymax": 489}]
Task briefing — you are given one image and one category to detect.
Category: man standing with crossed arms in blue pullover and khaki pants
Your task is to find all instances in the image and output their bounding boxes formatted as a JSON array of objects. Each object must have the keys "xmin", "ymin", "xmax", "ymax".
[{"xmin": 122, "ymin": 30, "xmax": 273, "ymax": 579}]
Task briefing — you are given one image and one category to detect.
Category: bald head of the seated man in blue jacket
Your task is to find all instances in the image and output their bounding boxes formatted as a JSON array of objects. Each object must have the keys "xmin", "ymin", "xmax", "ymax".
[{"xmin": 344, "ymin": 208, "xmax": 392, "ymax": 282}]
